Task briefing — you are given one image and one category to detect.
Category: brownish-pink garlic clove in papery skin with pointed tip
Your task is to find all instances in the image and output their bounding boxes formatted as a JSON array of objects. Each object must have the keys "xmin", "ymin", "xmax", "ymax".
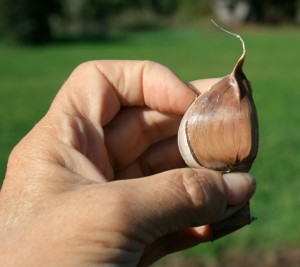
[{"xmin": 178, "ymin": 33, "xmax": 258, "ymax": 172}]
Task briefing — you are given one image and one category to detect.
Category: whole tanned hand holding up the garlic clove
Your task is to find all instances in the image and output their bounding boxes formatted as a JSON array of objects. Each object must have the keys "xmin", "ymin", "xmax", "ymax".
[{"xmin": 0, "ymin": 61, "xmax": 255, "ymax": 267}]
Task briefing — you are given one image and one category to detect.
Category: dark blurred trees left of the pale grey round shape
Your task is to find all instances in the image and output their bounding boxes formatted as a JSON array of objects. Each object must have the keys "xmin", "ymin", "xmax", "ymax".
[{"xmin": 0, "ymin": 0, "xmax": 210, "ymax": 43}]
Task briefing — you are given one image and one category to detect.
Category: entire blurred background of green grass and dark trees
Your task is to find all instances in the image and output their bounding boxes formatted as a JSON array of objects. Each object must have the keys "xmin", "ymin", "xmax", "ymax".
[{"xmin": 0, "ymin": 0, "xmax": 300, "ymax": 267}]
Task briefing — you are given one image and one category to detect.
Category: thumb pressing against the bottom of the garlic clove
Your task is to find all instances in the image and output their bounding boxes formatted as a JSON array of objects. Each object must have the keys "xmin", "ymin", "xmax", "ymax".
[{"xmin": 124, "ymin": 169, "xmax": 255, "ymax": 239}]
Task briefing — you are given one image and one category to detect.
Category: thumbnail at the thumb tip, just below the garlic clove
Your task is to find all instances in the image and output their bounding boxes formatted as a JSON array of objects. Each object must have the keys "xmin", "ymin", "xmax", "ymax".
[{"xmin": 223, "ymin": 172, "xmax": 255, "ymax": 206}]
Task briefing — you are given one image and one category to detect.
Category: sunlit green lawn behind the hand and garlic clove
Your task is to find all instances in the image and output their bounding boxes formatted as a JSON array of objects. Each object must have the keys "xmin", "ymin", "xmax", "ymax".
[{"xmin": 0, "ymin": 25, "xmax": 300, "ymax": 264}]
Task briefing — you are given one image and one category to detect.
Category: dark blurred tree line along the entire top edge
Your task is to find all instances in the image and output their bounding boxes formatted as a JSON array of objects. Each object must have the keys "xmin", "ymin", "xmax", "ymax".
[{"xmin": 0, "ymin": 0, "xmax": 298, "ymax": 43}]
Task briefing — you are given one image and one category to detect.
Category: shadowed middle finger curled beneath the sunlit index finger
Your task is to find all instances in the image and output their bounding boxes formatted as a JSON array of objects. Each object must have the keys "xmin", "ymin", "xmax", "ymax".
[{"xmin": 104, "ymin": 107, "xmax": 181, "ymax": 170}]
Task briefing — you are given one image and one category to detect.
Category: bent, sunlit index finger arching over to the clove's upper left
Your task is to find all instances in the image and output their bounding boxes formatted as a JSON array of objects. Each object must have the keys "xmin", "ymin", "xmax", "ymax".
[{"xmin": 54, "ymin": 60, "xmax": 195, "ymax": 126}]
